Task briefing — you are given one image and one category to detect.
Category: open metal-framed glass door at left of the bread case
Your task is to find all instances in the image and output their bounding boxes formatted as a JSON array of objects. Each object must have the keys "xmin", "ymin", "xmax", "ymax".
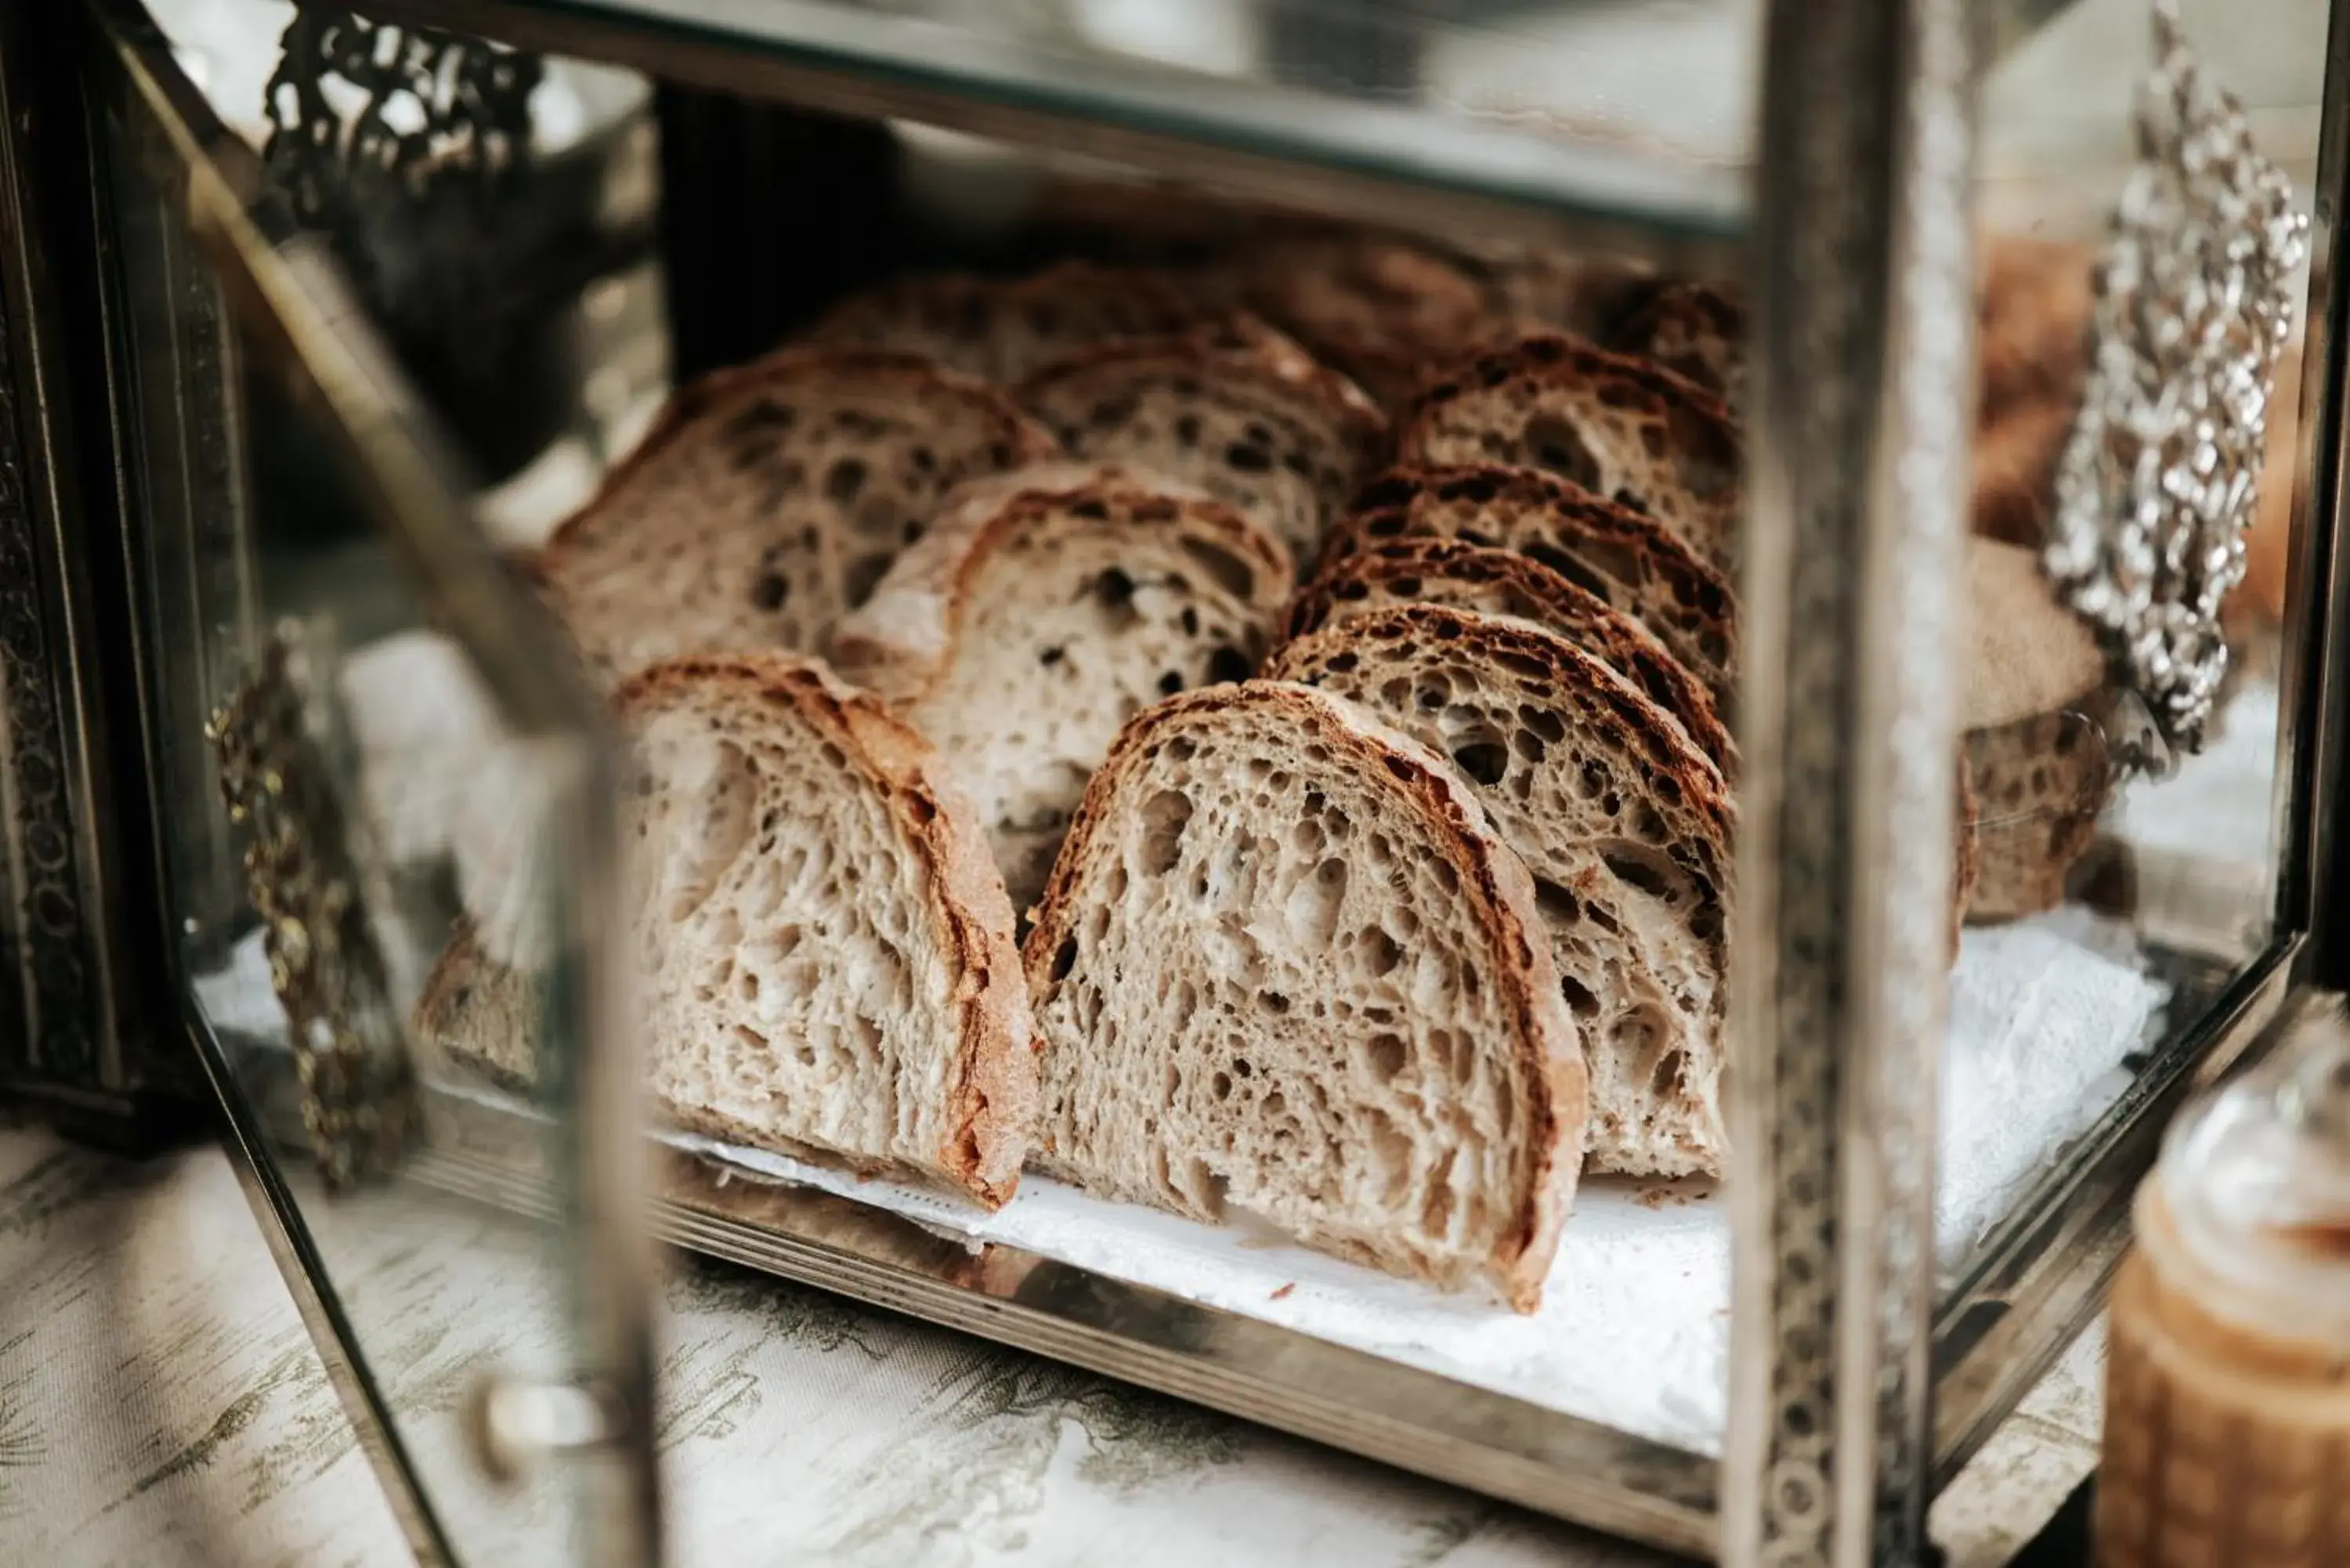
[{"xmin": 70, "ymin": 2, "xmax": 656, "ymax": 1563}]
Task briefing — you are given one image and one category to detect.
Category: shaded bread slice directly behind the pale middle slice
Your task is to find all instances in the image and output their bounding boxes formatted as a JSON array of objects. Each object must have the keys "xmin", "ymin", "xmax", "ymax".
[{"xmin": 1018, "ymin": 317, "xmax": 1386, "ymax": 559}]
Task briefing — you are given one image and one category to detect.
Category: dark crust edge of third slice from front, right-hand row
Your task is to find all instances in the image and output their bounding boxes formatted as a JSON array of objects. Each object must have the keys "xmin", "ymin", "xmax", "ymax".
[{"xmin": 1281, "ymin": 536, "xmax": 1739, "ymax": 778}]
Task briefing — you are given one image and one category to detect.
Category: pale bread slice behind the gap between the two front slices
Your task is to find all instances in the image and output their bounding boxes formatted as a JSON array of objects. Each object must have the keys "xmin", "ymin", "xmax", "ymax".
[{"xmin": 834, "ymin": 463, "xmax": 1295, "ymax": 910}]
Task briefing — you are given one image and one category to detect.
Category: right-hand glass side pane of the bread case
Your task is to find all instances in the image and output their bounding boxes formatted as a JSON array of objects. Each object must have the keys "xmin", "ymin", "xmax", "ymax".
[{"xmin": 1943, "ymin": 0, "xmax": 2329, "ymax": 1284}]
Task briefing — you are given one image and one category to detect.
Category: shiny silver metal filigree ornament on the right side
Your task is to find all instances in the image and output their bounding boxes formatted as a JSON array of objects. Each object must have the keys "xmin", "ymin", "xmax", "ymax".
[{"xmin": 2044, "ymin": 0, "xmax": 2308, "ymax": 768}]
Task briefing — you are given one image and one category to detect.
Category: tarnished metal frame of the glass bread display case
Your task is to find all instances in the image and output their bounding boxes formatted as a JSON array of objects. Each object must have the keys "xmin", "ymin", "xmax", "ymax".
[{"xmin": 0, "ymin": 0, "xmax": 2350, "ymax": 1568}]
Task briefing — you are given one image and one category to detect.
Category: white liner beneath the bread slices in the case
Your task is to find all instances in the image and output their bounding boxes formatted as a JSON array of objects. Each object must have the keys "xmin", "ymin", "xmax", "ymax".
[{"xmin": 197, "ymin": 667, "xmax": 2275, "ymax": 1453}]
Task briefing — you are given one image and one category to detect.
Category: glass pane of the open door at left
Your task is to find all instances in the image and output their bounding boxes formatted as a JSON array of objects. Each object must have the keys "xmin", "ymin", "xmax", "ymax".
[{"xmin": 99, "ymin": 15, "xmax": 625, "ymax": 1563}]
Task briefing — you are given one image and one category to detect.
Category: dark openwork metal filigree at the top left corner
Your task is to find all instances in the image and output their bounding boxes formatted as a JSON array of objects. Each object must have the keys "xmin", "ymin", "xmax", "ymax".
[{"xmin": 263, "ymin": 9, "xmax": 545, "ymax": 334}]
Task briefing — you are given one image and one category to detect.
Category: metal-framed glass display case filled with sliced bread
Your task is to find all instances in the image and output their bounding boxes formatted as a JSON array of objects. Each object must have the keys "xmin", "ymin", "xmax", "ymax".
[{"xmin": 0, "ymin": 0, "xmax": 2350, "ymax": 1566}]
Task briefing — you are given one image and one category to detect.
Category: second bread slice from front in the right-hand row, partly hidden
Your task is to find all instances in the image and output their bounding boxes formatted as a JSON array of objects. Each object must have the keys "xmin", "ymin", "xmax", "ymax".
[{"xmin": 1264, "ymin": 604, "xmax": 1734, "ymax": 1176}]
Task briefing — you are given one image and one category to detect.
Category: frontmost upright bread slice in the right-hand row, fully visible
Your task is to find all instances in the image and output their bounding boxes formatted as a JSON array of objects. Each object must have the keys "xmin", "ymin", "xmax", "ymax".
[{"xmin": 1027, "ymin": 681, "xmax": 1584, "ymax": 1312}]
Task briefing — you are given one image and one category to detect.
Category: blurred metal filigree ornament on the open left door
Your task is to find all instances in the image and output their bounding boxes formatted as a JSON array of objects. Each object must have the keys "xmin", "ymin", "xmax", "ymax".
[{"xmin": 204, "ymin": 623, "xmax": 418, "ymax": 1190}]
